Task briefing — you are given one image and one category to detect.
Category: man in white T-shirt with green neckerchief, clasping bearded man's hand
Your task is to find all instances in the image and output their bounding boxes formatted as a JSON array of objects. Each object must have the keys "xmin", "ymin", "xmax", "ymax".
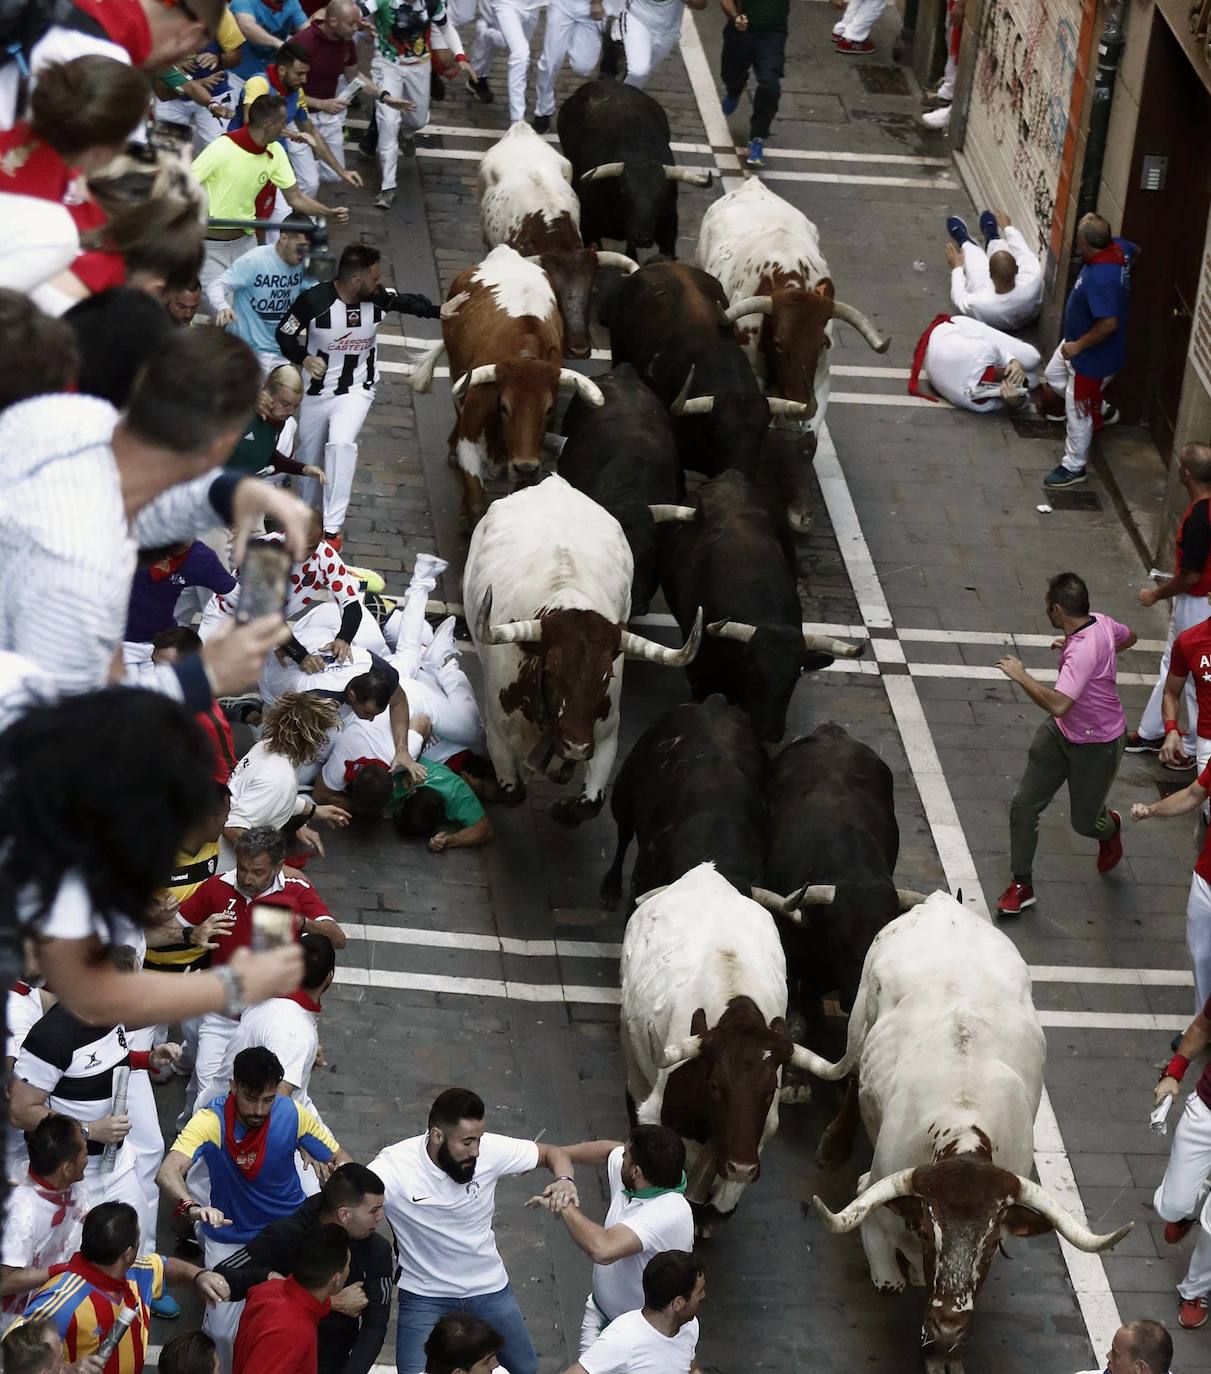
[{"xmin": 526, "ymin": 1125, "xmax": 694, "ymax": 1355}]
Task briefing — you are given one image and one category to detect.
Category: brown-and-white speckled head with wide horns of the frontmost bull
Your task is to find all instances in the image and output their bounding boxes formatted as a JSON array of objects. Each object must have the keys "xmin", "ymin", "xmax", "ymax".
[{"xmin": 811, "ymin": 1159, "xmax": 1131, "ymax": 1366}]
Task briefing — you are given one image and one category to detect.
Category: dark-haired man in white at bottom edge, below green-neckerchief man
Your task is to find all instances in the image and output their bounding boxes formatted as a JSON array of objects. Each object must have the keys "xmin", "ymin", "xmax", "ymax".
[{"xmin": 565, "ymin": 1250, "xmax": 707, "ymax": 1374}]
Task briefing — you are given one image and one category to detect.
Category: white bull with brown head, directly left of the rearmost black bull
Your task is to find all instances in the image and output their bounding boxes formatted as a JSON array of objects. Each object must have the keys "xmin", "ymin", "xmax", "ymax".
[{"xmin": 480, "ymin": 120, "xmax": 639, "ymax": 357}]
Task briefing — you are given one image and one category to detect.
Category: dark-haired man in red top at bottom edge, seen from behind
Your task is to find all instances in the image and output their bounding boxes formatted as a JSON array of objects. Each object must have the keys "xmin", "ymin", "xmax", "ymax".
[{"xmin": 232, "ymin": 1223, "xmax": 349, "ymax": 1374}]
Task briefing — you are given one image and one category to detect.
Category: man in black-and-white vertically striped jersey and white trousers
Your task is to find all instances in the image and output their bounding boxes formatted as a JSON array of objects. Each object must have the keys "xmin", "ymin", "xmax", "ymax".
[{"xmin": 278, "ymin": 243, "xmax": 441, "ymax": 548}]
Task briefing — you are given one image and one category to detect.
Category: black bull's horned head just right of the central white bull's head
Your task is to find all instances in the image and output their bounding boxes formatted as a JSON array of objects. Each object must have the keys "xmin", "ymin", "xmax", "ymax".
[{"xmin": 707, "ymin": 620, "xmax": 866, "ymax": 743}]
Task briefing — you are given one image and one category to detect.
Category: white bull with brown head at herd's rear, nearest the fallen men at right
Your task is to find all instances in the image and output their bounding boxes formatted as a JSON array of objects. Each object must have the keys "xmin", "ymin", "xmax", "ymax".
[{"xmin": 698, "ymin": 177, "xmax": 891, "ymax": 445}]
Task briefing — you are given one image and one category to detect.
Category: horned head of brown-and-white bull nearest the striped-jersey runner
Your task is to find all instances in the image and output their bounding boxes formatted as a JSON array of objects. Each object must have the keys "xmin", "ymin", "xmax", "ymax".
[{"xmin": 451, "ymin": 357, "xmax": 605, "ymax": 485}]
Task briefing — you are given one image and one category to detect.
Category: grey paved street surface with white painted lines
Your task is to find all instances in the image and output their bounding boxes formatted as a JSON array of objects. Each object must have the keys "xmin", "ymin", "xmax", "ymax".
[{"xmin": 151, "ymin": 0, "xmax": 1211, "ymax": 1374}]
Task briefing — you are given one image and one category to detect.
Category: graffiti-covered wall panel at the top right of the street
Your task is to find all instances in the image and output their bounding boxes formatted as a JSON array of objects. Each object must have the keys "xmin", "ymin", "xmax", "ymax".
[{"xmin": 969, "ymin": 0, "xmax": 1082, "ymax": 243}]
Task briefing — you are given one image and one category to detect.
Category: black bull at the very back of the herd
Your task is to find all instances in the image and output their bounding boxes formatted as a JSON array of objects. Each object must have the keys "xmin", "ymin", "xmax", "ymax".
[{"xmin": 557, "ymin": 81, "xmax": 711, "ymax": 258}]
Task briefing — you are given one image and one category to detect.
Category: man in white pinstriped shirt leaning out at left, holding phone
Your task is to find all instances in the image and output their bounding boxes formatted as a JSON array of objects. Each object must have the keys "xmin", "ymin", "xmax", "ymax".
[{"xmin": 0, "ymin": 330, "xmax": 316, "ymax": 710}]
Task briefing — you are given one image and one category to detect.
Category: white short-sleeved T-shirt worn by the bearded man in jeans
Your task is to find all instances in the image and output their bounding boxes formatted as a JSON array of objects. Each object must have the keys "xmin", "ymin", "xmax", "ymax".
[{"xmin": 370, "ymin": 1131, "xmax": 539, "ymax": 1297}]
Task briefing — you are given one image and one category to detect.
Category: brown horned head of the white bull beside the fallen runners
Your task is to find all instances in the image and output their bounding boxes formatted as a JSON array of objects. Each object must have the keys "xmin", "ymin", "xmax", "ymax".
[{"xmin": 476, "ymin": 591, "xmax": 702, "ymax": 763}]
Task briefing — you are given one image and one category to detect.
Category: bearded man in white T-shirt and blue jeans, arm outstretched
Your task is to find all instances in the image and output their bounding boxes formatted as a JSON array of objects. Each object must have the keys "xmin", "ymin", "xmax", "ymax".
[{"xmin": 370, "ymin": 1088, "xmax": 579, "ymax": 1374}]
